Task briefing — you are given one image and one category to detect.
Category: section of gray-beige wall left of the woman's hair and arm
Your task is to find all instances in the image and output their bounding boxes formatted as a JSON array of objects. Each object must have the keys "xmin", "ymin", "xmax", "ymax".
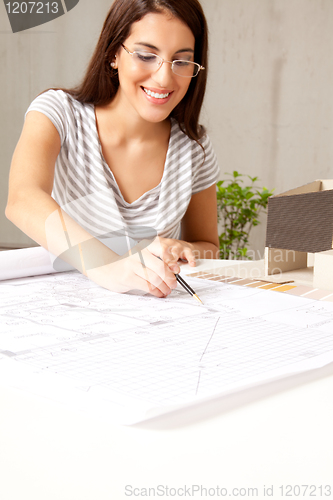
[{"xmin": 0, "ymin": 0, "xmax": 112, "ymax": 248}]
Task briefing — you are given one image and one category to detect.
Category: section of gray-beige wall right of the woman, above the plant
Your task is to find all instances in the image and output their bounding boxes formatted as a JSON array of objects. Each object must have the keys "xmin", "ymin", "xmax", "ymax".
[{"xmin": 202, "ymin": 0, "xmax": 333, "ymax": 252}]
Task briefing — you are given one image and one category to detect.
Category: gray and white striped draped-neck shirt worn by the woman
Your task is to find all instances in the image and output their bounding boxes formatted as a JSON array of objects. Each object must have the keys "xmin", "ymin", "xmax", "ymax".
[{"xmin": 27, "ymin": 90, "xmax": 219, "ymax": 246}]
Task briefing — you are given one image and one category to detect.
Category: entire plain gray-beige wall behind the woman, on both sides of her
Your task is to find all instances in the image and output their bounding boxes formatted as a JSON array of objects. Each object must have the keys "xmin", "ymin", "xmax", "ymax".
[{"xmin": 0, "ymin": 0, "xmax": 333, "ymax": 252}]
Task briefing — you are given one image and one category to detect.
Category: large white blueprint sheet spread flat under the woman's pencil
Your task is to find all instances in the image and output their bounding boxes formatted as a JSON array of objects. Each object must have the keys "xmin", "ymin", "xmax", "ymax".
[{"xmin": 0, "ymin": 272, "xmax": 333, "ymax": 424}]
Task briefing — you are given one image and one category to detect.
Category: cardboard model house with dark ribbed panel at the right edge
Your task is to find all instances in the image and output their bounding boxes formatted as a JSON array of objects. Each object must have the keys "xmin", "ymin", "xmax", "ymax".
[{"xmin": 265, "ymin": 180, "xmax": 333, "ymax": 289}]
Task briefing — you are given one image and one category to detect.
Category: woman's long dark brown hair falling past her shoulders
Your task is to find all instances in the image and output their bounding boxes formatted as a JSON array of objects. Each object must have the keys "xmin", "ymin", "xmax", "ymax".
[{"xmin": 59, "ymin": 0, "xmax": 208, "ymax": 141}]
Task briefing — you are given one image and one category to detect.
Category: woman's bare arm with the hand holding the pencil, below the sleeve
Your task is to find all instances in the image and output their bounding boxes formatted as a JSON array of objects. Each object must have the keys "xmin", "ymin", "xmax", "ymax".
[{"xmin": 6, "ymin": 111, "xmax": 177, "ymax": 297}]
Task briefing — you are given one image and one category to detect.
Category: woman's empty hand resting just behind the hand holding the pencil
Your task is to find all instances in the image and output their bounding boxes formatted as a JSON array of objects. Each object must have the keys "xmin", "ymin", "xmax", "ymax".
[{"xmin": 147, "ymin": 236, "xmax": 196, "ymax": 274}]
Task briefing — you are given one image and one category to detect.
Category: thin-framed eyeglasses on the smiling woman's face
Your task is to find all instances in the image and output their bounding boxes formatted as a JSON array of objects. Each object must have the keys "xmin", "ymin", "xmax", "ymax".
[{"xmin": 121, "ymin": 44, "xmax": 205, "ymax": 78}]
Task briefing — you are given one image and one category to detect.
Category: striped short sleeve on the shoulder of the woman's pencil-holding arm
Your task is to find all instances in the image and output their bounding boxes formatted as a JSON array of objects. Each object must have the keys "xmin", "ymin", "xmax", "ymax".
[{"xmin": 25, "ymin": 90, "xmax": 71, "ymax": 144}]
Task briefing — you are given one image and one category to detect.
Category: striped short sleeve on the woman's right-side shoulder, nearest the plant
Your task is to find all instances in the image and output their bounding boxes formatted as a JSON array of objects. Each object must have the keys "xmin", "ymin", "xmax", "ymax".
[{"xmin": 192, "ymin": 135, "xmax": 220, "ymax": 194}]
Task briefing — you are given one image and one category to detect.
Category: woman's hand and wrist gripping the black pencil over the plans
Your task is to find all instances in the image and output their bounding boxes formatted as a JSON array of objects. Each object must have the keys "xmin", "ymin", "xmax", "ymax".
[{"xmin": 87, "ymin": 245, "xmax": 179, "ymax": 297}]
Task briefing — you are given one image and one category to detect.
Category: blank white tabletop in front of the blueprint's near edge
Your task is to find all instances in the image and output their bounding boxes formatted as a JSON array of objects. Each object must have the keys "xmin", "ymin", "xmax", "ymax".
[{"xmin": 0, "ymin": 263, "xmax": 333, "ymax": 500}]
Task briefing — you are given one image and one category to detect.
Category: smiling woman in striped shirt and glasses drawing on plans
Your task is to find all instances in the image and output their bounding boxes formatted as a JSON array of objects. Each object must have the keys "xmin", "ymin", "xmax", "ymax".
[{"xmin": 6, "ymin": 0, "xmax": 218, "ymax": 297}]
